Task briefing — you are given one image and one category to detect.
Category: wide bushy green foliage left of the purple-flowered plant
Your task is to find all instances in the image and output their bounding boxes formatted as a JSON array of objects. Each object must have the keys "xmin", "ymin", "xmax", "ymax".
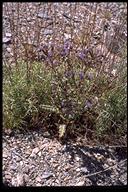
[{"xmin": 3, "ymin": 62, "xmax": 51, "ymax": 128}]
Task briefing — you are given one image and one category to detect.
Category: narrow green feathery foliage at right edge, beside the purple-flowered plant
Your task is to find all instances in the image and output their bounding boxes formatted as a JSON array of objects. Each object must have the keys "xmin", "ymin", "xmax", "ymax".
[{"xmin": 96, "ymin": 60, "xmax": 127, "ymax": 136}]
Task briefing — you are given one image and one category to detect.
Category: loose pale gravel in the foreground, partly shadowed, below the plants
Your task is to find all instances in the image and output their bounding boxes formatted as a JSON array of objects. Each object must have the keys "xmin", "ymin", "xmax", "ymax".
[{"xmin": 2, "ymin": 131, "xmax": 127, "ymax": 186}]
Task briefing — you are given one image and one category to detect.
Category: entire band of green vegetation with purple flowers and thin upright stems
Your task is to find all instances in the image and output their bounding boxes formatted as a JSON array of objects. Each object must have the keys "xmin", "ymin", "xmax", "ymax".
[{"xmin": 3, "ymin": 4, "xmax": 127, "ymax": 145}]
